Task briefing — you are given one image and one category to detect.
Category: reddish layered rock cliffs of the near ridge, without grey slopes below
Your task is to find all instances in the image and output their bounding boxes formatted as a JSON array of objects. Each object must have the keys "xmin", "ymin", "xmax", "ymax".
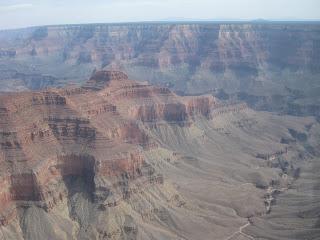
[{"xmin": 0, "ymin": 71, "xmax": 215, "ymax": 225}]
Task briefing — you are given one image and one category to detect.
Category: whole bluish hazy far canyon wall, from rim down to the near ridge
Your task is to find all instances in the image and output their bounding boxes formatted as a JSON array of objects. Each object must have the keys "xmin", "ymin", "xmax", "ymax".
[{"xmin": 0, "ymin": 22, "xmax": 320, "ymax": 116}]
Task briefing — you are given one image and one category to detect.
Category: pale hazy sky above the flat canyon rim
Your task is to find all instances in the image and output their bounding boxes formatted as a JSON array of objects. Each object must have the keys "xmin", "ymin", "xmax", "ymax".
[{"xmin": 0, "ymin": 0, "xmax": 320, "ymax": 29}]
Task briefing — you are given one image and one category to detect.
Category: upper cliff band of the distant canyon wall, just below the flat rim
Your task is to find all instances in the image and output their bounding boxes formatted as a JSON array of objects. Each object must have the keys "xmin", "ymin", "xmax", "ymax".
[{"xmin": 0, "ymin": 23, "xmax": 320, "ymax": 72}]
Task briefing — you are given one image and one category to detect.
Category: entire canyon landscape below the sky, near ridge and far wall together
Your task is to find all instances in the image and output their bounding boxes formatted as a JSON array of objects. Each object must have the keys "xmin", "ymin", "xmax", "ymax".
[{"xmin": 0, "ymin": 22, "xmax": 320, "ymax": 240}]
